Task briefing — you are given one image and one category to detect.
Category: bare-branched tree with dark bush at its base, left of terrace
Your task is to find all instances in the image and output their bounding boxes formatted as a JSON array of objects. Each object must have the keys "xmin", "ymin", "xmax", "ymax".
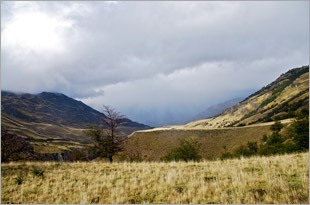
[{"xmin": 86, "ymin": 105, "xmax": 126, "ymax": 162}]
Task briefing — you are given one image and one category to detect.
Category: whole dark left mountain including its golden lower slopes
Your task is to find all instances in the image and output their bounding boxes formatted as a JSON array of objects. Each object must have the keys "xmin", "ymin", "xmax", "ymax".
[{"xmin": 1, "ymin": 91, "xmax": 151, "ymax": 156}]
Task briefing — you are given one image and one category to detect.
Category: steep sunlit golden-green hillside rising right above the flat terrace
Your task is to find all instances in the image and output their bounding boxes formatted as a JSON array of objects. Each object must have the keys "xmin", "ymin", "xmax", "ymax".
[{"xmin": 184, "ymin": 66, "xmax": 309, "ymax": 128}]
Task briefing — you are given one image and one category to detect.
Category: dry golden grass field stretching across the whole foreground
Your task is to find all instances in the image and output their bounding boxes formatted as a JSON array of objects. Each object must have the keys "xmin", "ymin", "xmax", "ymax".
[{"xmin": 1, "ymin": 153, "xmax": 309, "ymax": 204}]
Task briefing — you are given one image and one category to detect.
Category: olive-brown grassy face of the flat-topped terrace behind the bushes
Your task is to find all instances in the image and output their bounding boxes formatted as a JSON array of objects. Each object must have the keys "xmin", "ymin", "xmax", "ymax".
[{"xmin": 125, "ymin": 124, "xmax": 276, "ymax": 161}]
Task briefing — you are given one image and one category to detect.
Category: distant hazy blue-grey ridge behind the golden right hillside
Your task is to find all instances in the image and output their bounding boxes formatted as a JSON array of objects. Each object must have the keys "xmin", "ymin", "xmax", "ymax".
[{"xmin": 191, "ymin": 98, "xmax": 243, "ymax": 121}]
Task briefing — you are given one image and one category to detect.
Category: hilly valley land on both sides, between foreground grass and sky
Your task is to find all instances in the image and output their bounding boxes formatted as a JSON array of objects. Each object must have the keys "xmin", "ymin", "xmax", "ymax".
[{"xmin": 1, "ymin": 66, "xmax": 309, "ymax": 161}]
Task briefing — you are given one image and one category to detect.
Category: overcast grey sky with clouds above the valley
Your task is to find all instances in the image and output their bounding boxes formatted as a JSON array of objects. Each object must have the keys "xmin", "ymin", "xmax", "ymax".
[{"xmin": 1, "ymin": 1, "xmax": 309, "ymax": 126}]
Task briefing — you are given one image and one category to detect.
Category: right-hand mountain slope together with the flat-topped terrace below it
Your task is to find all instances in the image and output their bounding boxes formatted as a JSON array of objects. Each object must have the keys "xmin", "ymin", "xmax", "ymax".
[{"xmin": 126, "ymin": 66, "xmax": 309, "ymax": 161}]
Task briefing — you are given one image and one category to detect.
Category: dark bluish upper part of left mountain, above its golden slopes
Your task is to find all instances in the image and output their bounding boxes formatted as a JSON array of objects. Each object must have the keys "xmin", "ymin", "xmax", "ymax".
[{"xmin": 1, "ymin": 91, "xmax": 150, "ymax": 129}]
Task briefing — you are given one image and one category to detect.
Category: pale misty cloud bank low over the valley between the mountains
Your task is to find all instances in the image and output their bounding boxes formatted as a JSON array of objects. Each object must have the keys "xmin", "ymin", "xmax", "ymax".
[{"xmin": 80, "ymin": 54, "xmax": 308, "ymax": 126}]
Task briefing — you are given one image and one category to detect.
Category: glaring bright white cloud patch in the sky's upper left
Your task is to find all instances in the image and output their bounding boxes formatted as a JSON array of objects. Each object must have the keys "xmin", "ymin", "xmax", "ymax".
[{"xmin": 1, "ymin": 4, "xmax": 73, "ymax": 56}]
